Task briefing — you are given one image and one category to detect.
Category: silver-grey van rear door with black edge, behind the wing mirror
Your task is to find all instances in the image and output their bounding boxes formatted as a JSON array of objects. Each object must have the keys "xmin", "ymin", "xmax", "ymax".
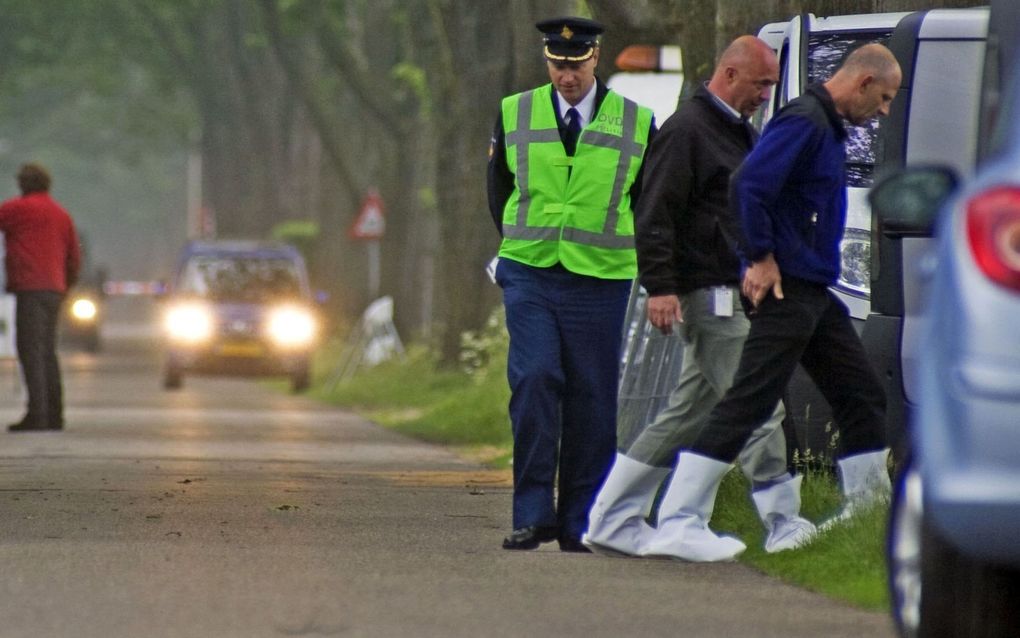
[{"xmin": 877, "ymin": 8, "xmax": 988, "ymax": 411}]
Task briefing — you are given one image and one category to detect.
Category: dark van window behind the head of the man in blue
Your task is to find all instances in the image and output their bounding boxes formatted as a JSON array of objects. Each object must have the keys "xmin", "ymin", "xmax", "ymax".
[{"xmin": 808, "ymin": 31, "xmax": 893, "ymax": 188}]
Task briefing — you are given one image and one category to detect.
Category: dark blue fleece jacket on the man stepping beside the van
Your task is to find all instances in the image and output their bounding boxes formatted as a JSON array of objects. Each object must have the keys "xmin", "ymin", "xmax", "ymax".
[{"xmin": 731, "ymin": 85, "xmax": 847, "ymax": 285}]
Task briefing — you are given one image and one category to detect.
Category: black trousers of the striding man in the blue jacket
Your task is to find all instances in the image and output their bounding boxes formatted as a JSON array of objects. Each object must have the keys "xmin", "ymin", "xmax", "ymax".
[{"xmin": 691, "ymin": 279, "xmax": 885, "ymax": 462}]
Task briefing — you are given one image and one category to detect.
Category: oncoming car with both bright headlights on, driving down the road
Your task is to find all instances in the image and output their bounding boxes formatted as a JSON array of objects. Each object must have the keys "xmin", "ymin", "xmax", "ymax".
[{"xmin": 162, "ymin": 241, "xmax": 319, "ymax": 392}]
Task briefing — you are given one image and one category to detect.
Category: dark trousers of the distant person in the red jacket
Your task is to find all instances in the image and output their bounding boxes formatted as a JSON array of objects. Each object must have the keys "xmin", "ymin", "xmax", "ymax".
[{"xmin": 14, "ymin": 290, "xmax": 63, "ymax": 427}]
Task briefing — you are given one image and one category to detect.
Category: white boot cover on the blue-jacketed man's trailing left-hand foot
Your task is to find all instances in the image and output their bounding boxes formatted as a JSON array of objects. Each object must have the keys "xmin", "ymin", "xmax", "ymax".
[{"xmin": 642, "ymin": 452, "xmax": 748, "ymax": 562}]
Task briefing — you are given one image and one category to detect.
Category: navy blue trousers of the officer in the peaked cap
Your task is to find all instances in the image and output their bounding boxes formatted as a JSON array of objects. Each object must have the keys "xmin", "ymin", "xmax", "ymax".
[{"xmin": 496, "ymin": 259, "xmax": 630, "ymax": 538}]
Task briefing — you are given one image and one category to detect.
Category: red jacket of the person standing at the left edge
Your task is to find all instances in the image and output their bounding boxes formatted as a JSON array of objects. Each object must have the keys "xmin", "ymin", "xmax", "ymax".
[{"xmin": 0, "ymin": 193, "xmax": 82, "ymax": 293}]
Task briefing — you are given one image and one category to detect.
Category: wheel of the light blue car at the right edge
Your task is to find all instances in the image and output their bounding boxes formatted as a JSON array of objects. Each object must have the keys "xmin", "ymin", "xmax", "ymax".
[{"xmin": 886, "ymin": 455, "xmax": 1020, "ymax": 638}]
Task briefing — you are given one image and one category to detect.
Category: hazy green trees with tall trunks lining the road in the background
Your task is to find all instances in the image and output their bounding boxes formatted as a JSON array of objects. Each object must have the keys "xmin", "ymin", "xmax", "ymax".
[{"xmin": 0, "ymin": 0, "xmax": 980, "ymax": 362}]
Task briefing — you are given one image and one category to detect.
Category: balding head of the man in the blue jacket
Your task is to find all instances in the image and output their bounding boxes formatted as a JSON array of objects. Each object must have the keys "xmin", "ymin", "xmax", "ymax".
[{"xmin": 825, "ymin": 44, "xmax": 903, "ymax": 125}]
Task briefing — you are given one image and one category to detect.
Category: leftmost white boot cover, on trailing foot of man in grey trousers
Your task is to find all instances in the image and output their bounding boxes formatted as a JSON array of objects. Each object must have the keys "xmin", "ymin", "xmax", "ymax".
[{"xmin": 581, "ymin": 453, "xmax": 669, "ymax": 555}]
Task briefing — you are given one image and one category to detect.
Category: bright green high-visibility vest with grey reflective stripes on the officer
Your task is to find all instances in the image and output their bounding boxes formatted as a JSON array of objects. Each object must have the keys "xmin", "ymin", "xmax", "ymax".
[{"xmin": 500, "ymin": 84, "xmax": 652, "ymax": 280}]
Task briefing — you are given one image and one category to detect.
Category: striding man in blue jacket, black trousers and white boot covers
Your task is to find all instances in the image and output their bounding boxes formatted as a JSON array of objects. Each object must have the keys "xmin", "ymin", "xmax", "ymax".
[{"xmin": 644, "ymin": 44, "xmax": 902, "ymax": 561}]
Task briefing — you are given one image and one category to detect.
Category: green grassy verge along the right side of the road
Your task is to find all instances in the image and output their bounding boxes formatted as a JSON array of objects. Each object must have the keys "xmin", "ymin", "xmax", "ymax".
[{"xmin": 311, "ymin": 321, "xmax": 888, "ymax": 610}]
